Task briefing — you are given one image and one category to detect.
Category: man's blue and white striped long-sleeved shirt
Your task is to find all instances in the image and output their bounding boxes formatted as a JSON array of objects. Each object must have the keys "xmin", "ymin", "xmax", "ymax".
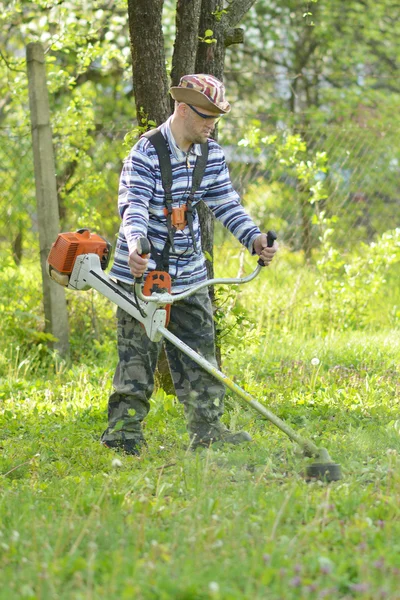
[{"xmin": 110, "ymin": 118, "xmax": 260, "ymax": 293}]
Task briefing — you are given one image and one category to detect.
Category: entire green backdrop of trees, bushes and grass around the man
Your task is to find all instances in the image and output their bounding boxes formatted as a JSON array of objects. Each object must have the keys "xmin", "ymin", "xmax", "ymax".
[{"xmin": 0, "ymin": 0, "xmax": 400, "ymax": 600}]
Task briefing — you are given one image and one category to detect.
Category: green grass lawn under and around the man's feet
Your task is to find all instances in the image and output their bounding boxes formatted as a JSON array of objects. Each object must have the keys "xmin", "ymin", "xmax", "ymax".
[{"xmin": 0, "ymin": 330, "xmax": 400, "ymax": 600}]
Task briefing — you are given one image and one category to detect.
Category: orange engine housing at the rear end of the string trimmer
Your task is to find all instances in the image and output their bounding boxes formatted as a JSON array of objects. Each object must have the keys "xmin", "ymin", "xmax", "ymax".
[{"xmin": 47, "ymin": 229, "xmax": 111, "ymax": 275}]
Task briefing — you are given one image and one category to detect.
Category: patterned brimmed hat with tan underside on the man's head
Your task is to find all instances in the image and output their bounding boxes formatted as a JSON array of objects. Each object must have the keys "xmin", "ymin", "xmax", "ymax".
[{"xmin": 169, "ymin": 73, "xmax": 231, "ymax": 114}]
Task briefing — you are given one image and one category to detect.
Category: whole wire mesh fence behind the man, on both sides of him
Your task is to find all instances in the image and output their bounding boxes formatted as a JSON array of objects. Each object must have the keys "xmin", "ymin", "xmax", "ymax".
[{"xmin": 0, "ymin": 125, "xmax": 400, "ymax": 264}]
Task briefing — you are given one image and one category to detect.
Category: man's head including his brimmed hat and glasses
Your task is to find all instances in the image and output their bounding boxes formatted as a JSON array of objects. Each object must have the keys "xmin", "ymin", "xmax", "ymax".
[{"xmin": 170, "ymin": 74, "xmax": 231, "ymax": 144}]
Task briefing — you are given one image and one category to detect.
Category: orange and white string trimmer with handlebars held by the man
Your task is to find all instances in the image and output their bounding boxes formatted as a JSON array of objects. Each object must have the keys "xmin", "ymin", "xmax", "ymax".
[{"xmin": 48, "ymin": 229, "xmax": 341, "ymax": 481}]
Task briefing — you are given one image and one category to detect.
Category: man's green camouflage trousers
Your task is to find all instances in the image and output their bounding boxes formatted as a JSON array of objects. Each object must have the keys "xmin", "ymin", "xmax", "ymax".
[{"xmin": 102, "ymin": 288, "xmax": 225, "ymax": 442}]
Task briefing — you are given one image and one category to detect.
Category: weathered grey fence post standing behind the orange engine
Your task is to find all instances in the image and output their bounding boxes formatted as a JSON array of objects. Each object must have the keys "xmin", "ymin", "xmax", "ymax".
[{"xmin": 26, "ymin": 42, "xmax": 69, "ymax": 356}]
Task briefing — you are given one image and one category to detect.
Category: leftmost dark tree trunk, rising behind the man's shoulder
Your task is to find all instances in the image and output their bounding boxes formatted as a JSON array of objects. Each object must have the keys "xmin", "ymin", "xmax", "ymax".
[{"xmin": 128, "ymin": 0, "xmax": 171, "ymax": 129}]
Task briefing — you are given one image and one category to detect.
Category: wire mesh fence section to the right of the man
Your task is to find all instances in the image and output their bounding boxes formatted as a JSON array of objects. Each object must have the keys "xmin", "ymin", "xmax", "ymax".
[{"xmin": 227, "ymin": 126, "xmax": 400, "ymax": 250}]
